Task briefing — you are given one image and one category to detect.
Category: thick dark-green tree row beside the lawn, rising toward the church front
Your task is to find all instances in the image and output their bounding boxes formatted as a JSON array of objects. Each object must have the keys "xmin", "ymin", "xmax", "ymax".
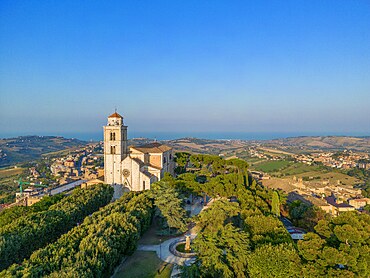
[{"xmin": 0, "ymin": 192, "xmax": 153, "ymax": 277}]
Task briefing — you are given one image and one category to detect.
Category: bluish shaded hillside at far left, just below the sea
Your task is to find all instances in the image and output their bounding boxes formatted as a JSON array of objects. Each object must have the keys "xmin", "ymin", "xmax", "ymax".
[{"xmin": 0, "ymin": 136, "xmax": 86, "ymax": 167}]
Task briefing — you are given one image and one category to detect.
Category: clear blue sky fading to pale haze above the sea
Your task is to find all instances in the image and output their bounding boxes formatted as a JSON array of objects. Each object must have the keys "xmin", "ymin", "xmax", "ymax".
[{"xmin": 0, "ymin": 0, "xmax": 370, "ymax": 136}]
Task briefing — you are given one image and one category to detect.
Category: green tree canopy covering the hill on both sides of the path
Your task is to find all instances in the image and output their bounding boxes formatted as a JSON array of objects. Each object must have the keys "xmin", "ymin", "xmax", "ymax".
[{"xmin": 0, "ymin": 153, "xmax": 370, "ymax": 277}]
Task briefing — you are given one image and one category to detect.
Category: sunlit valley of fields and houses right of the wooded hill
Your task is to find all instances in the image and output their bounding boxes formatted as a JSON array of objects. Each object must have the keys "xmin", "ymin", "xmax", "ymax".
[{"xmin": 165, "ymin": 136, "xmax": 370, "ymax": 216}]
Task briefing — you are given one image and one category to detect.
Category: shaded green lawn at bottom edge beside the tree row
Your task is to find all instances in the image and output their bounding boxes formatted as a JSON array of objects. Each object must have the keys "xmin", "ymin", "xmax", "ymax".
[{"xmin": 112, "ymin": 251, "xmax": 172, "ymax": 278}]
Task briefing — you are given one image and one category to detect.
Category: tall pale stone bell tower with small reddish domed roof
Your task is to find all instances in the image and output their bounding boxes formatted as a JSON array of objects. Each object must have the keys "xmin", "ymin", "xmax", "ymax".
[{"xmin": 103, "ymin": 112, "xmax": 128, "ymax": 184}]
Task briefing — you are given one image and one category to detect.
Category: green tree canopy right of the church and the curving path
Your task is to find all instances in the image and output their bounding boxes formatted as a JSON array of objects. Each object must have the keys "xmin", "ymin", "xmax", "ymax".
[{"xmin": 174, "ymin": 154, "xmax": 370, "ymax": 277}]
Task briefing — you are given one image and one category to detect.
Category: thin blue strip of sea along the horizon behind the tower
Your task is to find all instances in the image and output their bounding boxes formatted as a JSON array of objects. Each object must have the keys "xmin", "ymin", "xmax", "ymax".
[{"xmin": 0, "ymin": 131, "xmax": 370, "ymax": 141}]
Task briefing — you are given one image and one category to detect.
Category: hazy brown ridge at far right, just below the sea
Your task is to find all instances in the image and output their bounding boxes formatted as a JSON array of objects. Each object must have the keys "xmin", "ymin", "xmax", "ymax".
[{"xmin": 265, "ymin": 136, "xmax": 370, "ymax": 151}]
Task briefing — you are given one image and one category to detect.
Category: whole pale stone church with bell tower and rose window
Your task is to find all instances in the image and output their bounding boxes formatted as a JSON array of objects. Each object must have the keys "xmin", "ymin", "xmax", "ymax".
[{"xmin": 104, "ymin": 112, "xmax": 175, "ymax": 199}]
